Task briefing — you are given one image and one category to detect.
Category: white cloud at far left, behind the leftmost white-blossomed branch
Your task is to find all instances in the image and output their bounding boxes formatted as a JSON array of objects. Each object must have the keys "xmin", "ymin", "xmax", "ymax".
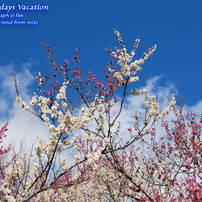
[{"xmin": 0, "ymin": 62, "xmax": 48, "ymax": 151}]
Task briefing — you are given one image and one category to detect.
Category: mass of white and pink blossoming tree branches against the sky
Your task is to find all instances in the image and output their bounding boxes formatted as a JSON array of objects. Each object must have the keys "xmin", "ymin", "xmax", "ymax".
[{"xmin": 0, "ymin": 30, "xmax": 202, "ymax": 202}]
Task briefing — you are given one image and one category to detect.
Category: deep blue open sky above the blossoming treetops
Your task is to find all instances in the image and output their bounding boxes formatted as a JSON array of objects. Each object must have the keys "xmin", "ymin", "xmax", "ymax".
[{"xmin": 0, "ymin": 0, "xmax": 202, "ymax": 147}]
